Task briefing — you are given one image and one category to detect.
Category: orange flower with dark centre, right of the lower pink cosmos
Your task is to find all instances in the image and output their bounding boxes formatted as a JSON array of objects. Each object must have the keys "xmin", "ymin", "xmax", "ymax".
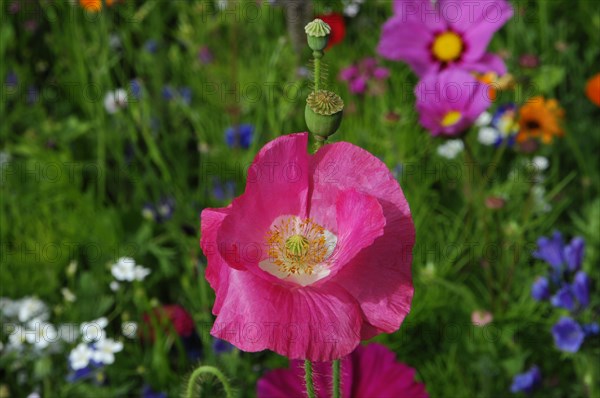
[{"xmin": 517, "ymin": 97, "xmax": 565, "ymax": 144}]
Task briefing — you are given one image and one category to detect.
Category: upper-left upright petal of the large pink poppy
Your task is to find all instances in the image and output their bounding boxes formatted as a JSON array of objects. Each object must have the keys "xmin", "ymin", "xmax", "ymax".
[{"xmin": 217, "ymin": 133, "xmax": 308, "ymax": 275}]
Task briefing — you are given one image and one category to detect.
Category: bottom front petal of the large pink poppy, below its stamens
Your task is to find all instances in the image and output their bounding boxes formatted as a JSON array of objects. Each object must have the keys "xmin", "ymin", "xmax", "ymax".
[{"xmin": 211, "ymin": 267, "xmax": 361, "ymax": 361}]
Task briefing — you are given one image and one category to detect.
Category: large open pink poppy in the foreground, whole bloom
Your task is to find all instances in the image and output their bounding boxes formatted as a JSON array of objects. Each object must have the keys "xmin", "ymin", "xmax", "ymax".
[{"xmin": 200, "ymin": 133, "xmax": 415, "ymax": 361}]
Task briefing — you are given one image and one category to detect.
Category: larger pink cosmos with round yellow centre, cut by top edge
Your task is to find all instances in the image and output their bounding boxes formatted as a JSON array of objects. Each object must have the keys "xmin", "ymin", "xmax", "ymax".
[{"xmin": 377, "ymin": 0, "xmax": 513, "ymax": 77}]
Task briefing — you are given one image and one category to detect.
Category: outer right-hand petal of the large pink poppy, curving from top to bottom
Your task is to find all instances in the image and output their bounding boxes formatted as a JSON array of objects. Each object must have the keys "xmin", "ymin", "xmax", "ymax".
[{"xmin": 310, "ymin": 142, "xmax": 415, "ymax": 338}]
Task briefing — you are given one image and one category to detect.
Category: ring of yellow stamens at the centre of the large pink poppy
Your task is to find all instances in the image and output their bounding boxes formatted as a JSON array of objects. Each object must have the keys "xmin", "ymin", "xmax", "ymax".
[{"xmin": 267, "ymin": 216, "xmax": 329, "ymax": 275}]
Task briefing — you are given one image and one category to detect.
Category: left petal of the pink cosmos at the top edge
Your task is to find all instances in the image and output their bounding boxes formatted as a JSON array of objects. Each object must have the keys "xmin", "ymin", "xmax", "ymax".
[{"xmin": 377, "ymin": 17, "xmax": 439, "ymax": 76}]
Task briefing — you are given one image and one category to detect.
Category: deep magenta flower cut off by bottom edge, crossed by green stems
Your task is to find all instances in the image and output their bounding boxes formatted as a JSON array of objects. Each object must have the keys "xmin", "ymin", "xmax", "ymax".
[{"xmin": 256, "ymin": 344, "xmax": 428, "ymax": 398}]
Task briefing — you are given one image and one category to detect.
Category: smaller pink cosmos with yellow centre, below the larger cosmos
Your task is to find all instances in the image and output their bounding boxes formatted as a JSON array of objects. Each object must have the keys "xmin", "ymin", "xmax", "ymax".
[{"xmin": 415, "ymin": 69, "xmax": 491, "ymax": 137}]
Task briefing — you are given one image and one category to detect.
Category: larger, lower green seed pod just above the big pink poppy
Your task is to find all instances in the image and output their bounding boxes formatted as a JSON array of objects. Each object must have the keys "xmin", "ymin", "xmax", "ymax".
[{"xmin": 304, "ymin": 90, "xmax": 344, "ymax": 141}]
